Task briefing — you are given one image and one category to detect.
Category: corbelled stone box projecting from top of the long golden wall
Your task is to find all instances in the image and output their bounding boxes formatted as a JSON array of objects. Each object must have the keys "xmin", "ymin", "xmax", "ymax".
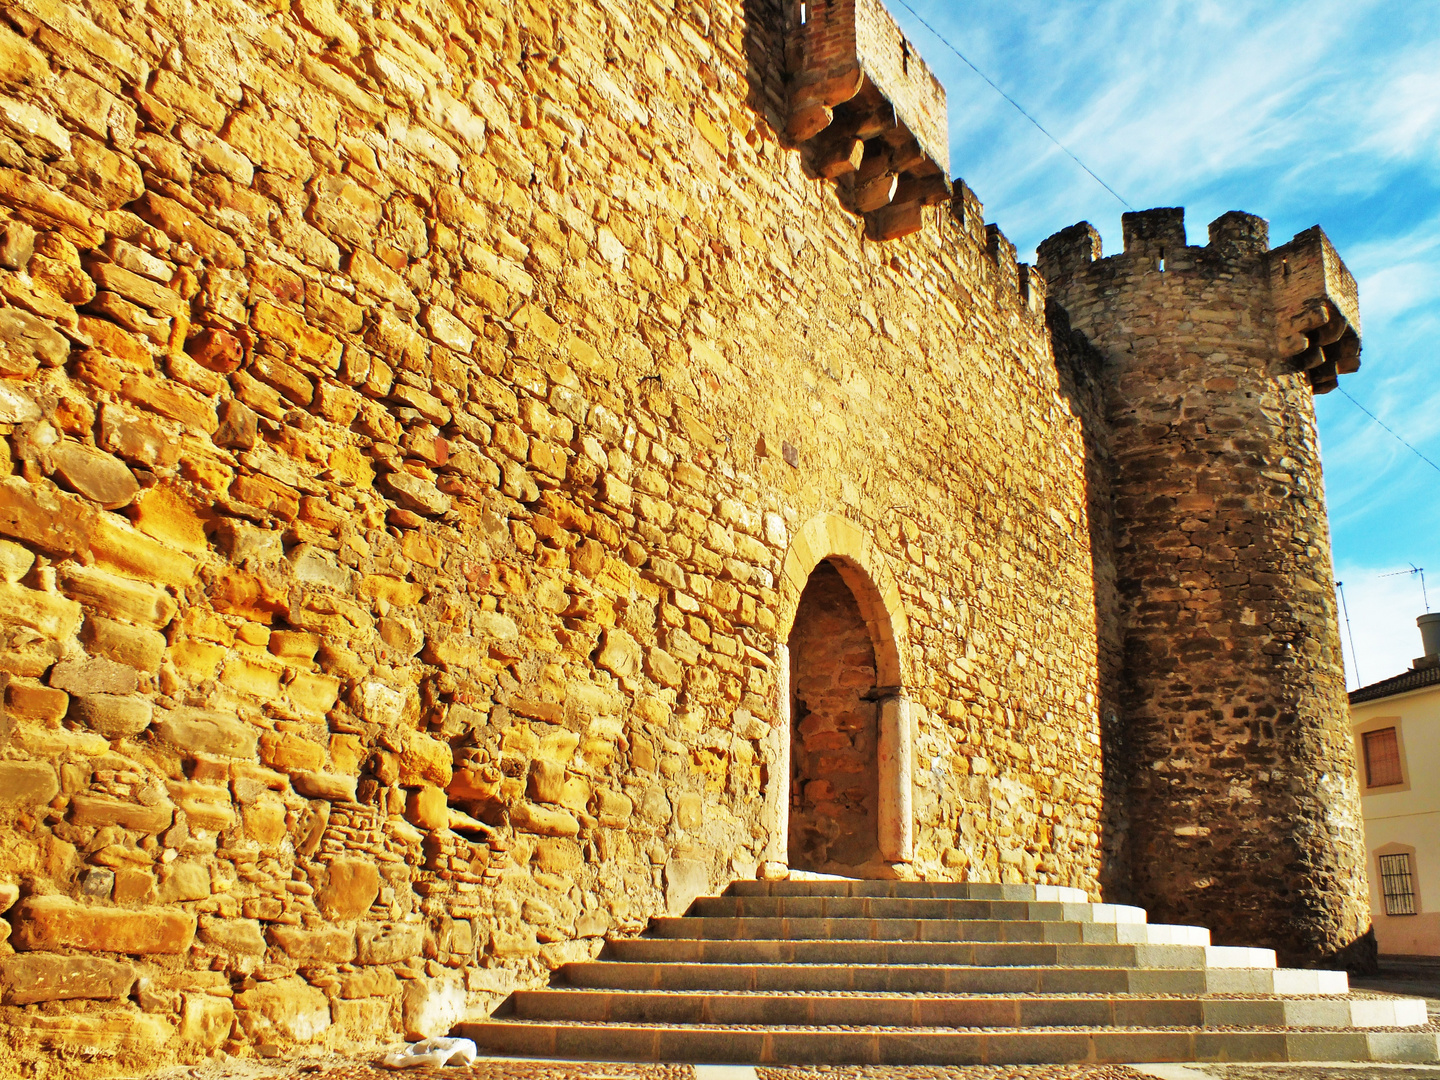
[{"xmin": 785, "ymin": 0, "xmax": 950, "ymax": 240}]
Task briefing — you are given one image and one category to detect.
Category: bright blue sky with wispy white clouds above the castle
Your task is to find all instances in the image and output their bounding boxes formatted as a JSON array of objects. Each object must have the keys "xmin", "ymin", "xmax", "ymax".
[{"xmin": 887, "ymin": 0, "xmax": 1440, "ymax": 687}]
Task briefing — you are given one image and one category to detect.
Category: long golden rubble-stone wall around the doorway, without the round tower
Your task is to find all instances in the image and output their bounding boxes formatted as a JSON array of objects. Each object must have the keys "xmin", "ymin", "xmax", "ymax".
[{"xmin": 0, "ymin": 0, "xmax": 1119, "ymax": 1063}]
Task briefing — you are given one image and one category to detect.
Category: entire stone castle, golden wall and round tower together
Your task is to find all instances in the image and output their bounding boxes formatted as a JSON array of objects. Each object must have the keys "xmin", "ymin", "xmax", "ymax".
[{"xmin": 0, "ymin": 0, "xmax": 1368, "ymax": 1073}]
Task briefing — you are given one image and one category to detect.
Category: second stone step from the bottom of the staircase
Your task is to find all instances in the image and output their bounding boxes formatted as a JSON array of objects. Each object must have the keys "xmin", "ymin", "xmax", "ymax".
[{"xmin": 507, "ymin": 988, "xmax": 1427, "ymax": 1028}]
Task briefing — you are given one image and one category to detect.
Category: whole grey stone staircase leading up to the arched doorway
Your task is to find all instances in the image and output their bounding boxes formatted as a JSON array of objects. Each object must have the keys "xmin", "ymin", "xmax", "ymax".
[{"xmin": 455, "ymin": 880, "xmax": 1440, "ymax": 1064}]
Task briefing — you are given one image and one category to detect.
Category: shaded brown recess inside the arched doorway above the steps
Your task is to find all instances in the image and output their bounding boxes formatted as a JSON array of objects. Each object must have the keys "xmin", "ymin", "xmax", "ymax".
[{"xmin": 788, "ymin": 559, "xmax": 881, "ymax": 871}]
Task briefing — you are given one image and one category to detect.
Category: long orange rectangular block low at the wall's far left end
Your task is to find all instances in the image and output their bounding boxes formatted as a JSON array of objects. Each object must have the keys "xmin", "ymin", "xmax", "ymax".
[{"xmin": 10, "ymin": 896, "xmax": 196, "ymax": 955}]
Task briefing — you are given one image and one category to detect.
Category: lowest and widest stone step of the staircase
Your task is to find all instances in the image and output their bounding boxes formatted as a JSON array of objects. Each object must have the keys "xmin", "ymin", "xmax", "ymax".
[{"xmin": 452, "ymin": 1020, "xmax": 1440, "ymax": 1066}]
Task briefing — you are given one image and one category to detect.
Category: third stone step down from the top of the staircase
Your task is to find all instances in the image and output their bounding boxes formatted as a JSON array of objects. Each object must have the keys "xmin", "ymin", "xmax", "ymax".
[{"xmin": 649, "ymin": 916, "xmax": 1210, "ymax": 946}]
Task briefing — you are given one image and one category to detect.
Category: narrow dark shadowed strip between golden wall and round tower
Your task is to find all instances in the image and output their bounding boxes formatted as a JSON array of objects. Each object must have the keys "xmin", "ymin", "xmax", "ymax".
[{"xmin": 1045, "ymin": 301, "xmax": 1133, "ymax": 903}]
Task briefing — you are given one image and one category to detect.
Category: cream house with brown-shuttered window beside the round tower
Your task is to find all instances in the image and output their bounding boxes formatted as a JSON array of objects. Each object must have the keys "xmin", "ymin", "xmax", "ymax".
[{"xmin": 1349, "ymin": 613, "xmax": 1440, "ymax": 956}]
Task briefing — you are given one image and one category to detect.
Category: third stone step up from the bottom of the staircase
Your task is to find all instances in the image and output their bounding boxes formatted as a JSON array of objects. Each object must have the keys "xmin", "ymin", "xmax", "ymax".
[{"xmin": 560, "ymin": 960, "xmax": 1349, "ymax": 996}]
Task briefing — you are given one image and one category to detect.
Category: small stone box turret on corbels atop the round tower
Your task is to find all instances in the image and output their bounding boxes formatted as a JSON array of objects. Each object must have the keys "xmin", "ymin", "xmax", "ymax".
[{"xmin": 1269, "ymin": 225, "xmax": 1361, "ymax": 393}]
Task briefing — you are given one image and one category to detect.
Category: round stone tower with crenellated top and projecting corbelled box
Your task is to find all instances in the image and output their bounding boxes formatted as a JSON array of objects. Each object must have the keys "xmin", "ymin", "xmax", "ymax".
[{"xmin": 1038, "ymin": 209, "xmax": 1374, "ymax": 968}]
